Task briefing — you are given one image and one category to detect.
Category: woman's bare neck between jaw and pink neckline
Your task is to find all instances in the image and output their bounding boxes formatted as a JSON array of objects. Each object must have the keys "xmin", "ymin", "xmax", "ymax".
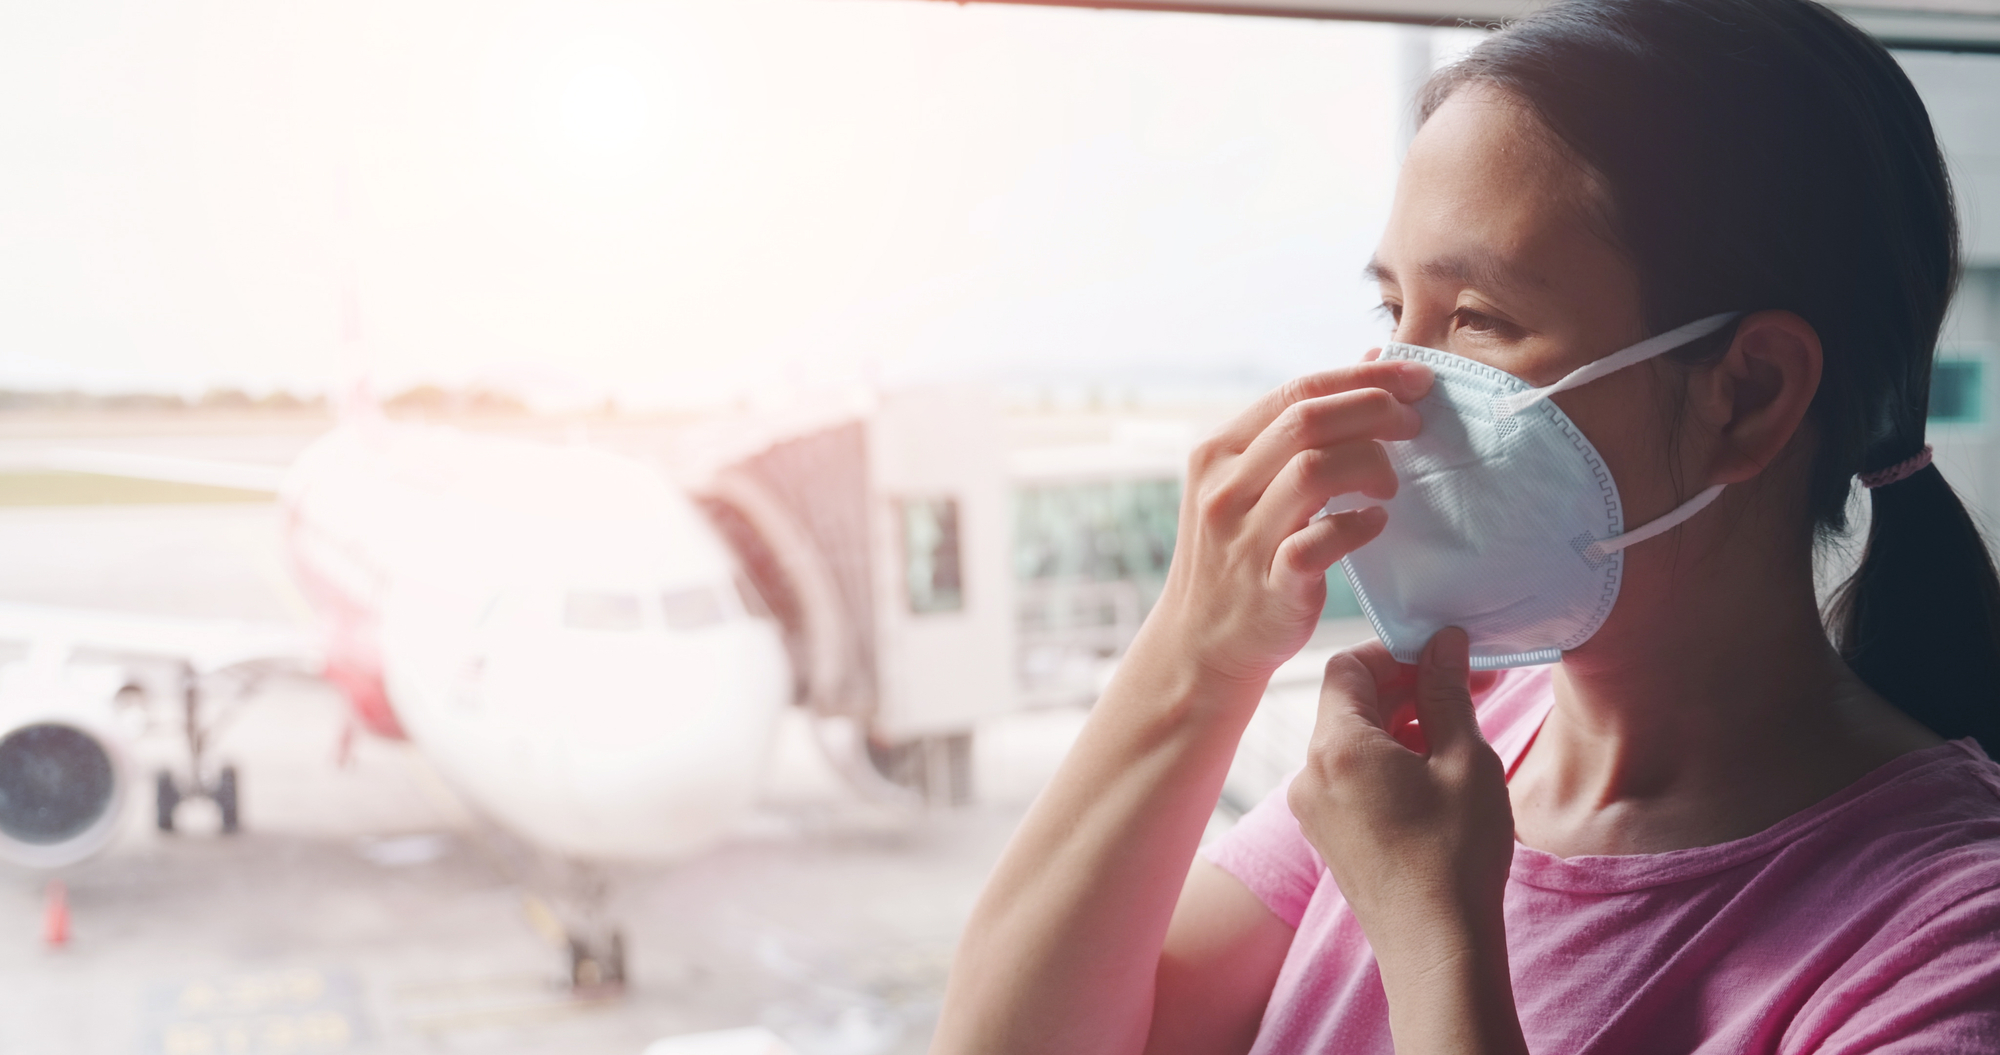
[{"xmin": 1512, "ymin": 503, "xmax": 1936, "ymax": 855}]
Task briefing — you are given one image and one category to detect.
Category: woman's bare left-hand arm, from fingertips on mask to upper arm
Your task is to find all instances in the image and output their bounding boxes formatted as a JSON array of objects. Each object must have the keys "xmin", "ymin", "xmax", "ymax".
[{"xmin": 932, "ymin": 362, "xmax": 1430, "ymax": 1055}]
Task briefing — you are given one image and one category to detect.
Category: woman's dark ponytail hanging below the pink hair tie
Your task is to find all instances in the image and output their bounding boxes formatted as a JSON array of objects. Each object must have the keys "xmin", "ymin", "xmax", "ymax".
[{"xmin": 1828, "ymin": 466, "xmax": 2000, "ymax": 757}]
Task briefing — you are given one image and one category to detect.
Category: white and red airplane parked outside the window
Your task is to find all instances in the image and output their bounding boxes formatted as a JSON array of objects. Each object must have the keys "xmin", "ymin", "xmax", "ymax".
[{"xmin": 0, "ymin": 420, "xmax": 794, "ymax": 975}]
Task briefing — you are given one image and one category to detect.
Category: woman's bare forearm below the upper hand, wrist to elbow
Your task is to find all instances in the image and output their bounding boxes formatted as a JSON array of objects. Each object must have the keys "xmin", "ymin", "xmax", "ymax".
[{"xmin": 934, "ymin": 635, "xmax": 1260, "ymax": 1055}]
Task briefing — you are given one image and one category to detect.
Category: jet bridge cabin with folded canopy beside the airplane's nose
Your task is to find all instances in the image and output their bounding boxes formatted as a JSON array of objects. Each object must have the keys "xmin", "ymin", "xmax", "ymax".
[{"xmin": 696, "ymin": 390, "xmax": 1016, "ymax": 803}]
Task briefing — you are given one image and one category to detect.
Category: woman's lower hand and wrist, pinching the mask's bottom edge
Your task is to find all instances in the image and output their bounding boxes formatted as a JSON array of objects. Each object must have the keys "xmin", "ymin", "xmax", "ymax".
[{"xmin": 1288, "ymin": 627, "xmax": 1524, "ymax": 1051}]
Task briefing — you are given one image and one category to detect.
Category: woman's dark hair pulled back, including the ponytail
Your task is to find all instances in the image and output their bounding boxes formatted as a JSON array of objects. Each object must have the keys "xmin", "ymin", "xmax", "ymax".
[{"xmin": 1420, "ymin": 0, "xmax": 2000, "ymax": 755}]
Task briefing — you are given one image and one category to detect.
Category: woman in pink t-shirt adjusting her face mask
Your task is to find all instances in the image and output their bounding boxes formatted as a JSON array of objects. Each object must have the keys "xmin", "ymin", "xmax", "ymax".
[{"xmin": 936, "ymin": 0, "xmax": 2000, "ymax": 1055}]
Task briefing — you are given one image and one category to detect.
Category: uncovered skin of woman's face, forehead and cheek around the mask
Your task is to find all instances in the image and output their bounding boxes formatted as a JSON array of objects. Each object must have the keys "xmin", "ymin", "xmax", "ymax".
[{"xmin": 1370, "ymin": 84, "xmax": 1752, "ymax": 655}]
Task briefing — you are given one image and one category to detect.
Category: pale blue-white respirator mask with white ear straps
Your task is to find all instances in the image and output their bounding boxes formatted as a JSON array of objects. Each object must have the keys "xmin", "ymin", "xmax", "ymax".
[{"xmin": 1326, "ymin": 312, "xmax": 1736, "ymax": 669}]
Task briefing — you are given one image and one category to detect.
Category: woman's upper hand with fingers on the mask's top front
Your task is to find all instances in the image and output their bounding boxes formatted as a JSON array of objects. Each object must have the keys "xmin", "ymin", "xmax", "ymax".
[{"xmin": 1132, "ymin": 360, "xmax": 1432, "ymax": 687}]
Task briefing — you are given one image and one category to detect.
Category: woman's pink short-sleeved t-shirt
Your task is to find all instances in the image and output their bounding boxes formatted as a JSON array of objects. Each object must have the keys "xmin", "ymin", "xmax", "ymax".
[{"xmin": 1202, "ymin": 667, "xmax": 2000, "ymax": 1055}]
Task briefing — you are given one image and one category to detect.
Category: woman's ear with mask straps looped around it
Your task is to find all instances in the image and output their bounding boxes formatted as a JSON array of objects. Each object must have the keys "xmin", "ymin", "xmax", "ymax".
[{"xmin": 1690, "ymin": 312, "xmax": 1824, "ymax": 484}]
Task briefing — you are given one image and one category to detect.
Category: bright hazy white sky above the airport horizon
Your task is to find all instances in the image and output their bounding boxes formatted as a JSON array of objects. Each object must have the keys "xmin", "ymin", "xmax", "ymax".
[{"xmin": 0, "ymin": 0, "xmax": 1412, "ymax": 406}]
